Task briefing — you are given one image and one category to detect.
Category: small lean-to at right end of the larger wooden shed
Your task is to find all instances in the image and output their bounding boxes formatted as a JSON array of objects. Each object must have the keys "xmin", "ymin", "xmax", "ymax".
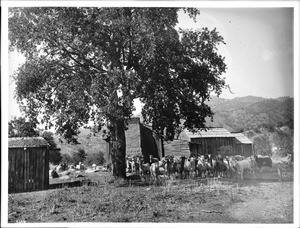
[{"xmin": 231, "ymin": 133, "xmax": 253, "ymax": 157}]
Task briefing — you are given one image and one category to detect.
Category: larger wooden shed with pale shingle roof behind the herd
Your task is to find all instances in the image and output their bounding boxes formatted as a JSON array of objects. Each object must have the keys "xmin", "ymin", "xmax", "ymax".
[{"xmin": 178, "ymin": 127, "xmax": 235, "ymax": 157}]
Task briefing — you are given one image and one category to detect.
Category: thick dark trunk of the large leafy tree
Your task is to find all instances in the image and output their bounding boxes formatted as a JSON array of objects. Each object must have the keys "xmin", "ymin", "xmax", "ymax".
[{"xmin": 109, "ymin": 119, "xmax": 126, "ymax": 178}]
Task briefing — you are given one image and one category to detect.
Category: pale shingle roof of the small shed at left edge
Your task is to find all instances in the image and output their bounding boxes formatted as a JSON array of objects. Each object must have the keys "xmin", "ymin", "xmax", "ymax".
[{"xmin": 8, "ymin": 137, "xmax": 48, "ymax": 148}]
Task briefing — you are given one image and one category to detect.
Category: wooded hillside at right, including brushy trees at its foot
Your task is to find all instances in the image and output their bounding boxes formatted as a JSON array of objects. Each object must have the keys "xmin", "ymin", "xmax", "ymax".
[{"xmin": 206, "ymin": 96, "xmax": 294, "ymax": 156}]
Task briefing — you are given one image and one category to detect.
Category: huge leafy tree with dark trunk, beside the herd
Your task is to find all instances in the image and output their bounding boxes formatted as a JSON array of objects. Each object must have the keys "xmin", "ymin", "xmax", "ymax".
[{"xmin": 9, "ymin": 8, "xmax": 226, "ymax": 178}]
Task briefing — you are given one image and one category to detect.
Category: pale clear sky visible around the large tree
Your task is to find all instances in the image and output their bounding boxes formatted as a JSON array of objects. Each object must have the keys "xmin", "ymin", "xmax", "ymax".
[{"xmin": 9, "ymin": 7, "xmax": 294, "ymax": 116}]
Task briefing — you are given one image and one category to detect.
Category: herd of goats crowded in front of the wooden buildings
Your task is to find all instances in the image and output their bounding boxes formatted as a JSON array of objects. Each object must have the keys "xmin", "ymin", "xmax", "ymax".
[{"xmin": 126, "ymin": 154, "xmax": 291, "ymax": 180}]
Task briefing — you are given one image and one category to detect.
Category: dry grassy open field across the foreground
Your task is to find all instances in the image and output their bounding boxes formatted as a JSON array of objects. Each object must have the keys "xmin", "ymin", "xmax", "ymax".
[{"xmin": 8, "ymin": 167, "xmax": 293, "ymax": 223}]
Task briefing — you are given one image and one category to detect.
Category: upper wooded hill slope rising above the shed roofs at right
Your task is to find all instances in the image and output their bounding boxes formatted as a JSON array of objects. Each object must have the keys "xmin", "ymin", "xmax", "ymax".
[{"xmin": 207, "ymin": 96, "xmax": 294, "ymax": 132}]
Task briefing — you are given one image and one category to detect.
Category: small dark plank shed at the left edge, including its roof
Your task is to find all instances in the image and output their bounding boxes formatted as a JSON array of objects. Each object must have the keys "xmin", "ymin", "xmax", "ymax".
[{"xmin": 8, "ymin": 137, "xmax": 49, "ymax": 193}]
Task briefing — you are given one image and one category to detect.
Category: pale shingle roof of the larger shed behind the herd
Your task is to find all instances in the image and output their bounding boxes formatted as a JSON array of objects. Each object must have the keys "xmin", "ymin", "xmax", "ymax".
[{"xmin": 183, "ymin": 127, "xmax": 234, "ymax": 139}]
